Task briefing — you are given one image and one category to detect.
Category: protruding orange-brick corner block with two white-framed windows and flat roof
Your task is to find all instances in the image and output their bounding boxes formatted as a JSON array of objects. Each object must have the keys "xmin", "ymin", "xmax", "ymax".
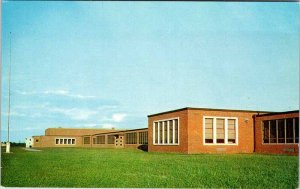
[{"xmin": 148, "ymin": 108, "xmax": 268, "ymax": 154}]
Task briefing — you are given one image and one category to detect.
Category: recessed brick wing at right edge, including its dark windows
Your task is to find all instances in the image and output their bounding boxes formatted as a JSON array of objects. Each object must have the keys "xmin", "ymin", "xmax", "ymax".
[{"xmin": 253, "ymin": 110, "xmax": 299, "ymax": 155}]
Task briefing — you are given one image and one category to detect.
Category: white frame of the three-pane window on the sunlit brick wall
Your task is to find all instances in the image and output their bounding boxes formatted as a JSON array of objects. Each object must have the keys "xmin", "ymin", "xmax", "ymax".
[{"xmin": 202, "ymin": 116, "xmax": 239, "ymax": 146}]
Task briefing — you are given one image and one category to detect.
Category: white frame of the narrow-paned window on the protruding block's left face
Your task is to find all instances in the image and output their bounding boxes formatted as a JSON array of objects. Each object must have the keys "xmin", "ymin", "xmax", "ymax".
[{"xmin": 152, "ymin": 117, "xmax": 180, "ymax": 146}]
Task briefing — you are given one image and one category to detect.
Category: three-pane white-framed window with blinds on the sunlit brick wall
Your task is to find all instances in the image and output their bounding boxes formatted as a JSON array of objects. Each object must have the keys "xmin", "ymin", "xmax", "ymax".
[{"xmin": 203, "ymin": 116, "xmax": 238, "ymax": 144}]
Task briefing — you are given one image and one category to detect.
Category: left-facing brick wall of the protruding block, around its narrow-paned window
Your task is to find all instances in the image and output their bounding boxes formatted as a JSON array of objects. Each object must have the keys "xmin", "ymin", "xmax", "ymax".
[{"xmin": 148, "ymin": 110, "xmax": 188, "ymax": 153}]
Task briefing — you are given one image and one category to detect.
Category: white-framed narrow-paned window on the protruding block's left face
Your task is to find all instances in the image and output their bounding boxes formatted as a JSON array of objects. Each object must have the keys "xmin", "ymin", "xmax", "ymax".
[{"xmin": 153, "ymin": 118, "xmax": 179, "ymax": 145}]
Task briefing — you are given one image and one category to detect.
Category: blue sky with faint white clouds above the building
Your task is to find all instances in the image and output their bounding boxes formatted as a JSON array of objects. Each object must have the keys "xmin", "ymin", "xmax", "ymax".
[{"xmin": 1, "ymin": 1, "xmax": 299, "ymax": 142}]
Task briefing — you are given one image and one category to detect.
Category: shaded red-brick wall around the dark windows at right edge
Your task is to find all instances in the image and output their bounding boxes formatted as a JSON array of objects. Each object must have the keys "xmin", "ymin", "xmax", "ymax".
[{"xmin": 255, "ymin": 113, "xmax": 299, "ymax": 155}]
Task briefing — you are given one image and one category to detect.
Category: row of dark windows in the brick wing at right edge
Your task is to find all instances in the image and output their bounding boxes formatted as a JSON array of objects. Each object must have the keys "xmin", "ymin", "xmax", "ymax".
[{"xmin": 262, "ymin": 118, "xmax": 299, "ymax": 144}]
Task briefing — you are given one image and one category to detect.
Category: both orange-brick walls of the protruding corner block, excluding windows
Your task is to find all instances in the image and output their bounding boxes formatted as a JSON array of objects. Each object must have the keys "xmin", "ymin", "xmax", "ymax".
[{"xmin": 148, "ymin": 109, "xmax": 255, "ymax": 154}]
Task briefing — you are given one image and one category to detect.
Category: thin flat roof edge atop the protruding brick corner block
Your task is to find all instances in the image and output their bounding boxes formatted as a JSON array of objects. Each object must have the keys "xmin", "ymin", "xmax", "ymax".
[{"xmin": 148, "ymin": 107, "xmax": 273, "ymax": 117}]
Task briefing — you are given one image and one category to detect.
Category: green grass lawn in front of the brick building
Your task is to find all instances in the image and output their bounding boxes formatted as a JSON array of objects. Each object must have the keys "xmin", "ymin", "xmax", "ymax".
[{"xmin": 1, "ymin": 148, "xmax": 298, "ymax": 188}]
